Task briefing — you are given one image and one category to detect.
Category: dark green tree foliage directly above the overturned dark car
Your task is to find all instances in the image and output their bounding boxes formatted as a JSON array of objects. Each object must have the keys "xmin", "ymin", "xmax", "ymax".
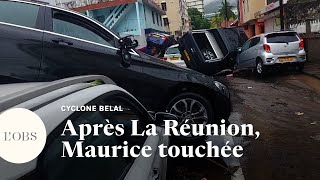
[{"xmin": 188, "ymin": 8, "xmax": 211, "ymax": 30}]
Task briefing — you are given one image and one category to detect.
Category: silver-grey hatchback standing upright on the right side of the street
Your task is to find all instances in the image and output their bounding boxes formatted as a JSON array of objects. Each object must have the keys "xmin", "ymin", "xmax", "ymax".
[{"xmin": 235, "ymin": 31, "xmax": 306, "ymax": 75}]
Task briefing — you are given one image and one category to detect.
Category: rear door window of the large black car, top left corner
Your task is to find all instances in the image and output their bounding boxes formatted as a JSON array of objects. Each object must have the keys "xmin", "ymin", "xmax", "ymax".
[{"xmin": 0, "ymin": 1, "xmax": 39, "ymax": 28}]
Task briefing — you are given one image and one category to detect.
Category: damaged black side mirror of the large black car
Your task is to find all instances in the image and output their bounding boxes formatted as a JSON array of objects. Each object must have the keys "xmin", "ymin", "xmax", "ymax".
[{"xmin": 118, "ymin": 36, "xmax": 139, "ymax": 68}]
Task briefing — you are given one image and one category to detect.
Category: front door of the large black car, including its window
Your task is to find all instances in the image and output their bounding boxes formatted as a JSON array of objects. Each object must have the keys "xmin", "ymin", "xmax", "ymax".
[{"xmin": 41, "ymin": 8, "xmax": 142, "ymax": 95}]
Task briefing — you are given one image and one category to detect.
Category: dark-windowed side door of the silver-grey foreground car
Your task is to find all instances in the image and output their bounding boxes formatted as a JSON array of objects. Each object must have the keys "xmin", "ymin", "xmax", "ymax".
[{"xmin": 38, "ymin": 92, "xmax": 168, "ymax": 180}]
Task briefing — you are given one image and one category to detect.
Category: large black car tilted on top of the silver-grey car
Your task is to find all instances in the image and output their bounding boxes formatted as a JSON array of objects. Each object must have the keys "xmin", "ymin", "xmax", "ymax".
[{"xmin": 0, "ymin": 0, "xmax": 231, "ymax": 123}]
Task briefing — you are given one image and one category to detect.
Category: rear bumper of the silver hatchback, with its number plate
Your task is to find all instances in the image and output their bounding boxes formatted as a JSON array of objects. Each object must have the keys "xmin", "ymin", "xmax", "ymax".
[{"xmin": 262, "ymin": 50, "xmax": 306, "ymax": 66}]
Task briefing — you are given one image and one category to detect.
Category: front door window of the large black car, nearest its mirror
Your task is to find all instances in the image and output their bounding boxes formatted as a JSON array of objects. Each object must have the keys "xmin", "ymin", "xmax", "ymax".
[{"xmin": 52, "ymin": 10, "xmax": 114, "ymax": 46}]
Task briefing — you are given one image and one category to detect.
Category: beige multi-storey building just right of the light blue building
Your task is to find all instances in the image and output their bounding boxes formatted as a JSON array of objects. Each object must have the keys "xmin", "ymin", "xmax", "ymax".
[{"xmin": 156, "ymin": 0, "xmax": 190, "ymax": 37}]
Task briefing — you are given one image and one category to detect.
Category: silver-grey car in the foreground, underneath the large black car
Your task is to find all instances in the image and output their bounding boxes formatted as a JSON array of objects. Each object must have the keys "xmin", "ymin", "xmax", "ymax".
[{"xmin": 0, "ymin": 76, "xmax": 174, "ymax": 180}]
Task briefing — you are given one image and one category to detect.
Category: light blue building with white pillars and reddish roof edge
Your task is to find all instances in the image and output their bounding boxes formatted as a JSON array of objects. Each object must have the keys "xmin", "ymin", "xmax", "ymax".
[{"xmin": 56, "ymin": 0, "xmax": 165, "ymax": 47}]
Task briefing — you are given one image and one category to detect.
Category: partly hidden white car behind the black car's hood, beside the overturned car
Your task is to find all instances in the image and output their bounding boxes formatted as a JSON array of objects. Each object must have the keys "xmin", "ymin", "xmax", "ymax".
[{"xmin": 162, "ymin": 44, "xmax": 186, "ymax": 67}]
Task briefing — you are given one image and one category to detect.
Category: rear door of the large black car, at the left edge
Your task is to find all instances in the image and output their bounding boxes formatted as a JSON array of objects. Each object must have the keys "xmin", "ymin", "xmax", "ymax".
[{"xmin": 0, "ymin": 1, "xmax": 44, "ymax": 83}]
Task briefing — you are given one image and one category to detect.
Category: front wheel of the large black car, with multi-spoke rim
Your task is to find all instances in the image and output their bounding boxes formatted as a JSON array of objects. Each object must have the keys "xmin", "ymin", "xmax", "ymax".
[{"xmin": 167, "ymin": 93, "xmax": 213, "ymax": 125}]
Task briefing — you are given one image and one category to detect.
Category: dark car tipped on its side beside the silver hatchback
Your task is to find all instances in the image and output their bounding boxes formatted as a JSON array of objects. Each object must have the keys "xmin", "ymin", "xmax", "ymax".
[{"xmin": 179, "ymin": 27, "xmax": 248, "ymax": 75}]
